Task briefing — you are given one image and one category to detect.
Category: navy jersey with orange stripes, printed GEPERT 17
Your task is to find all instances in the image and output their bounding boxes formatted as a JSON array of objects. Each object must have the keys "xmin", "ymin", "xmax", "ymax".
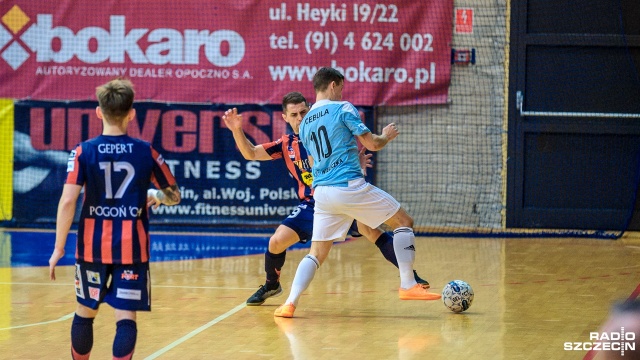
[{"xmin": 66, "ymin": 135, "xmax": 176, "ymax": 264}]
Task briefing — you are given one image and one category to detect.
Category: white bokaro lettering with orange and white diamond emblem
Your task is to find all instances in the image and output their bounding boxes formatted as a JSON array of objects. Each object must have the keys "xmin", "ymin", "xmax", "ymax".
[{"xmin": 0, "ymin": 5, "xmax": 245, "ymax": 70}]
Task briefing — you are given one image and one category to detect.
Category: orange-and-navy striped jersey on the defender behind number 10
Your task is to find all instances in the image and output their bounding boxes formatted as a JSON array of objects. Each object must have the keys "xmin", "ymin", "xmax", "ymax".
[{"xmin": 262, "ymin": 134, "xmax": 313, "ymax": 201}]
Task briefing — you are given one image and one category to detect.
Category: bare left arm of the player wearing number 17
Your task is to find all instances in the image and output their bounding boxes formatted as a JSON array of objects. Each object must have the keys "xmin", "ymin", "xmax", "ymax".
[{"xmin": 49, "ymin": 184, "xmax": 82, "ymax": 280}]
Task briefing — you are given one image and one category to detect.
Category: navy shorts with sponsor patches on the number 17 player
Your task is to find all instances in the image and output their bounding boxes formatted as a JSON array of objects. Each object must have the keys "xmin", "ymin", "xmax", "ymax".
[{"xmin": 76, "ymin": 262, "xmax": 151, "ymax": 311}]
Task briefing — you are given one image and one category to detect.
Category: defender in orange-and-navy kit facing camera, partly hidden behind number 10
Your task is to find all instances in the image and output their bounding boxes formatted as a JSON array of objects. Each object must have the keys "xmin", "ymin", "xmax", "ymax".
[{"xmin": 222, "ymin": 92, "xmax": 429, "ymax": 305}]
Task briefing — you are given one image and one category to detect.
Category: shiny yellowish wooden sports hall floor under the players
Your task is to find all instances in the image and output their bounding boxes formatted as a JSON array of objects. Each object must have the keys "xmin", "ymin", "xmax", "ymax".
[{"xmin": 0, "ymin": 235, "xmax": 640, "ymax": 360}]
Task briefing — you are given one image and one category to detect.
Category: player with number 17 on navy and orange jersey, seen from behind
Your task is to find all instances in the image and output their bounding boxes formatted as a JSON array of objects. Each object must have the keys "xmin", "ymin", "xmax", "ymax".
[{"xmin": 49, "ymin": 79, "xmax": 180, "ymax": 359}]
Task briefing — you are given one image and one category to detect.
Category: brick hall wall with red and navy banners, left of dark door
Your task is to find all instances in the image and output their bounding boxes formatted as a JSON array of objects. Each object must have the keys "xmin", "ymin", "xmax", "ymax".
[{"xmin": 0, "ymin": 0, "xmax": 508, "ymax": 232}]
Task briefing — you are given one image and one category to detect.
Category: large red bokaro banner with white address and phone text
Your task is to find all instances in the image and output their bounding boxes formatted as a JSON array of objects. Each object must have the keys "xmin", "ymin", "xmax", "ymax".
[{"xmin": 0, "ymin": 0, "xmax": 453, "ymax": 106}]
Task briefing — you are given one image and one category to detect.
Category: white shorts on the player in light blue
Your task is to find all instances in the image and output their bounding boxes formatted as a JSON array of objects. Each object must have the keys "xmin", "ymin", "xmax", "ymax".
[{"xmin": 311, "ymin": 179, "xmax": 400, "ymax": 241}]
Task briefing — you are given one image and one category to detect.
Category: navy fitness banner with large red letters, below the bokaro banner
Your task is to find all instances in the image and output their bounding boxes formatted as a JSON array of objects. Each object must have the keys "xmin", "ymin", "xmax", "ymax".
[{"xmin": 13, "ymin": 101, "xmax": 374, "ymax": 225}]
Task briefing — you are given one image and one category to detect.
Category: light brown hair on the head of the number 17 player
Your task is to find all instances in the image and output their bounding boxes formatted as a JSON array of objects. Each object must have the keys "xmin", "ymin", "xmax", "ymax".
[{"xmin": 96, "ymin": 79, "xmax": 135, "ymax": 121}]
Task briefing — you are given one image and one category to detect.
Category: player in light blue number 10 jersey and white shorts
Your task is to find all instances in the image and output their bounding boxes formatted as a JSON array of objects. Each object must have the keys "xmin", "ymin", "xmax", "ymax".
[{"xmin": 274, "ymin": 67, "xmax": 441, "ymax": 317}]
